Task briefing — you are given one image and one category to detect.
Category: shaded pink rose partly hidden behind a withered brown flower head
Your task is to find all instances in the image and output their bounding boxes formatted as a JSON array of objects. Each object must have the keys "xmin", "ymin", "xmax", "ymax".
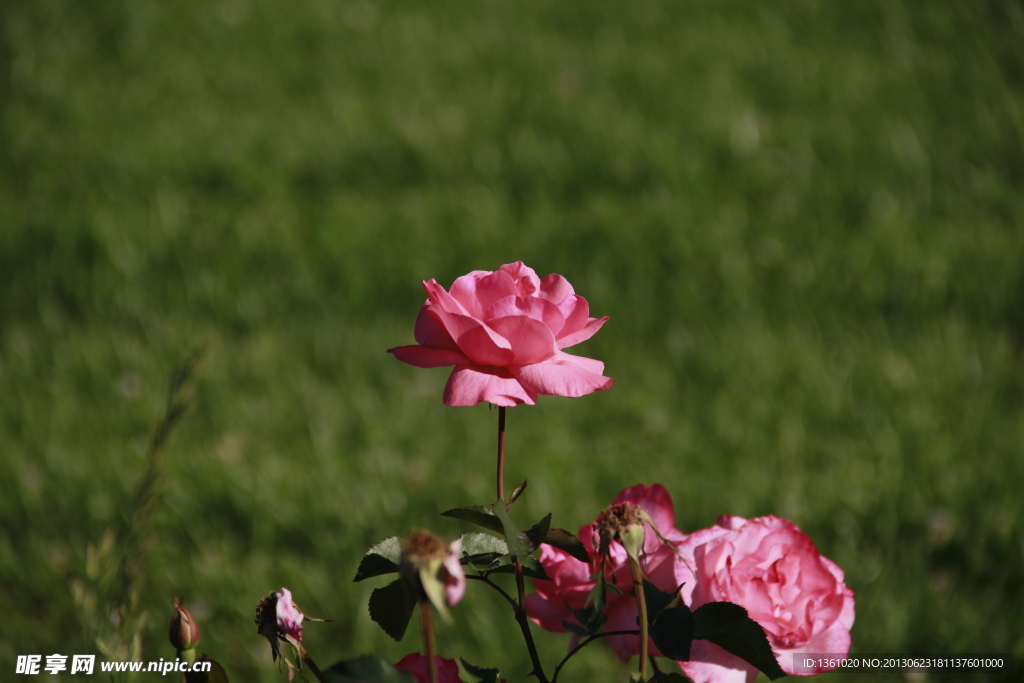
[{"xmin": 526, "ymin": 484, "xmax": 692, "ymax": 661}]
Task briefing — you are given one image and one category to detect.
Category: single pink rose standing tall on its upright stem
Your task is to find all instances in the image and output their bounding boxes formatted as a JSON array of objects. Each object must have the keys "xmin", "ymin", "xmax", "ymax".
[{"xmin": 388, "ymin": 261, "xmax": 611, "ymax": 405}]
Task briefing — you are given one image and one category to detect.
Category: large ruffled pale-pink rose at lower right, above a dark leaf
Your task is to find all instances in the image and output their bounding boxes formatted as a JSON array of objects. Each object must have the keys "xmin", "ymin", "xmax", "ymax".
[{"xmin": 680, "ymin": 515, "xmax": 854, "ymax": 683}]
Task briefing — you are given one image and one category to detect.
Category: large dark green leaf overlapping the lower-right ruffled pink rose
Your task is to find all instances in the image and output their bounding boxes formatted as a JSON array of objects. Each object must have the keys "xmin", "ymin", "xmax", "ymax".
[{"xmin": 696, "ymin": 602, "xmax": 785, "ymax": 681}]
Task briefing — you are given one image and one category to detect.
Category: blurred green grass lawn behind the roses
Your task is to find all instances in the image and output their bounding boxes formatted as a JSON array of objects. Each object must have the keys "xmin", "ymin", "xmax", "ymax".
[{"xmin": 0, "ymin": 0, "xmax": 1024, "ymax": 681}]
